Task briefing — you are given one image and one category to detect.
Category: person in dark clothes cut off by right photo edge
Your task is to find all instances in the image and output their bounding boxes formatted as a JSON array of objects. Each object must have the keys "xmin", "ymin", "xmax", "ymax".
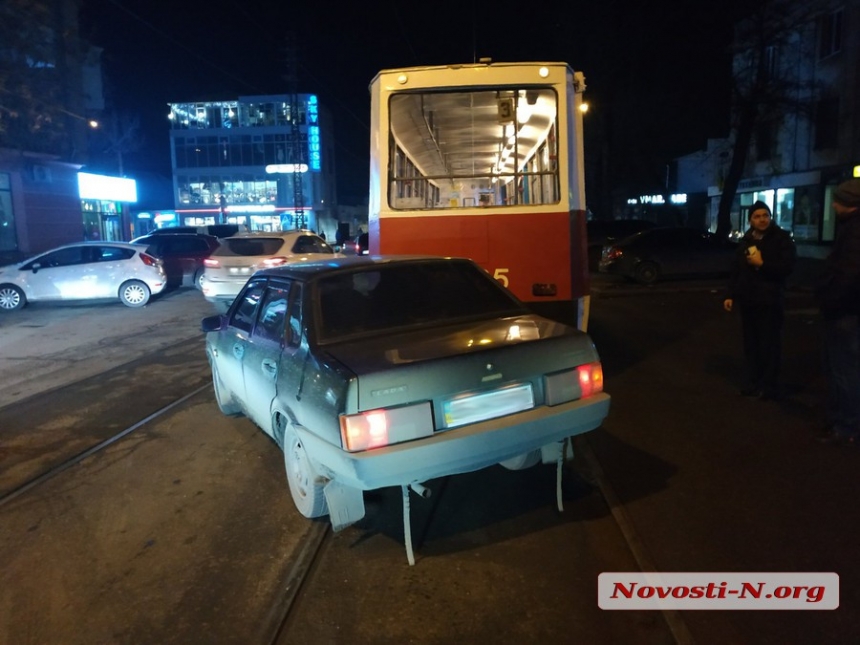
[{"xmin": 815, "ymin": 179, "xmax": 860, "ymax": 446}]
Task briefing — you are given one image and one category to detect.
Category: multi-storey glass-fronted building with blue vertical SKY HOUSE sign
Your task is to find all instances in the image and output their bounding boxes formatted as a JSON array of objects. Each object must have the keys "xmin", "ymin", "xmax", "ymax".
[{"xmin": 169, "ymin": 94, "xmax": 336, "ymax": 232}]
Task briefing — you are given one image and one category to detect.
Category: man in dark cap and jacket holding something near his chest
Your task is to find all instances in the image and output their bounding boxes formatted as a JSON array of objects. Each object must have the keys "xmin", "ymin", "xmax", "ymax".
[{"xmin": 723, "ymin": 202, "xmax": 797, "ymax": 400}]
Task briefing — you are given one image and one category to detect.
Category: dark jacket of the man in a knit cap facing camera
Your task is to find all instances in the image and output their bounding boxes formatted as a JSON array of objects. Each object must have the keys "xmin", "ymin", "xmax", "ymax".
[{"xmin": 729, "ymin": 223, "xmax": 797, "ymax": 307}]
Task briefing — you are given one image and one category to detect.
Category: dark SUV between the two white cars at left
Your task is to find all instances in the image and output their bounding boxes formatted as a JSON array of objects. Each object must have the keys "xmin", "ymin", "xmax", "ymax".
[{"xmin": 132, "ymin": 233, "xmax": 218, "ymax": 288}]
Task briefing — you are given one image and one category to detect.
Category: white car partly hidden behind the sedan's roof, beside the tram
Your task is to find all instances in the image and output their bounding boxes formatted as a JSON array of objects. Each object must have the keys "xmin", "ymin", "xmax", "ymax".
[{"xmin": 200, "ymin": 230, "xmax": 343, "ymax": 311}]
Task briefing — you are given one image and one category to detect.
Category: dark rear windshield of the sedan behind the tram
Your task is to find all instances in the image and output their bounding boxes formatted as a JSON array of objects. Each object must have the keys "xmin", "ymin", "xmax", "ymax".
[{"xmin": 318, "ymin": 261, "xmax": 525, "ymax": 342}]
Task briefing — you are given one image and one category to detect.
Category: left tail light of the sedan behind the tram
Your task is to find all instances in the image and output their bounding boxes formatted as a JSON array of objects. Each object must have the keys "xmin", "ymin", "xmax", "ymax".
[{"xmin": 340, "ymin": 401, "xmax": 433, "ymax": 452}]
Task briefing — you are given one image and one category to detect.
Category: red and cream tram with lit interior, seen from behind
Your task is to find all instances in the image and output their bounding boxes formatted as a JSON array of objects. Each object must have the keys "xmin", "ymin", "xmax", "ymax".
[{"xmin": 368, "ymin": 59, "xmax": 589, "ymax": 330}]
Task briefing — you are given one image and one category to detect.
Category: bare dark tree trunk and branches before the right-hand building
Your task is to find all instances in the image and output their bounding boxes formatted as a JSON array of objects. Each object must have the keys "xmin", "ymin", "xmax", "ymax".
[{"xmin": 717, "ymin": 0, "xmax": 832, "ymax": 236}]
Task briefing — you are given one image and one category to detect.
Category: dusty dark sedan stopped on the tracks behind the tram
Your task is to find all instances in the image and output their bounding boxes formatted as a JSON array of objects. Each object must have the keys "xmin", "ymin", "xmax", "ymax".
[{"xmin": 201, "ymin": 256, "xmax": 609, "ymax": 560}]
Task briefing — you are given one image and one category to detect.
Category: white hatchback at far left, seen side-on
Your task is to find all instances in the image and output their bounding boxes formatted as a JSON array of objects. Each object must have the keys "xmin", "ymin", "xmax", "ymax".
[{"xmin": 0, "ymin": 242, "xmax": 167, "ymax": 311}]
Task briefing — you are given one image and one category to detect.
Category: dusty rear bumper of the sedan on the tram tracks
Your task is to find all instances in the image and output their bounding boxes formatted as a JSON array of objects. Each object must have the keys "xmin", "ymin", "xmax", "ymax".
[{"xmin": 296, "ymin": 393, "xmax": 610, "ymax": 490}]
